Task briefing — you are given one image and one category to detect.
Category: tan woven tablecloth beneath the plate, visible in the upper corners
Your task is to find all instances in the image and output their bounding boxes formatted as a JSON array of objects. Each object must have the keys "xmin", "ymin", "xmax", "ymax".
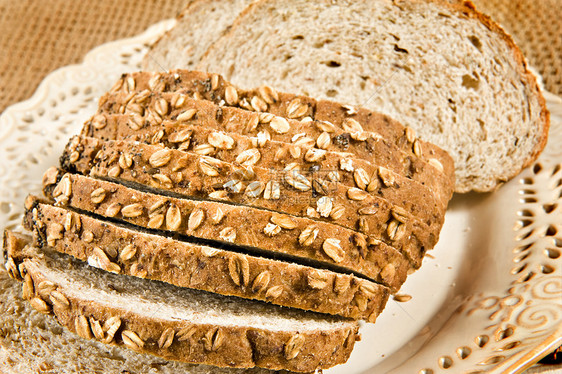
[{"xmin": 0, "ymin": 0, "xmax": 562, "ymax": 373}]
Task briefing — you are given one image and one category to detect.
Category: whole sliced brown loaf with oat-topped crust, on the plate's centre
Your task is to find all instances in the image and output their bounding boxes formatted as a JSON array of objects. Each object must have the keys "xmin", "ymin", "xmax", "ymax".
[{"xmin": 4, "ymin": 70, "xmax": 455, "ymax": 372}]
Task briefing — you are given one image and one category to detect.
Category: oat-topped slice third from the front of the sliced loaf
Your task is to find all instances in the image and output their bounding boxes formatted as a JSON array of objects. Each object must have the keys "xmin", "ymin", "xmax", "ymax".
[{"xmin": 39, "ymin": 172, "xmax": 406, "ymax": 290}]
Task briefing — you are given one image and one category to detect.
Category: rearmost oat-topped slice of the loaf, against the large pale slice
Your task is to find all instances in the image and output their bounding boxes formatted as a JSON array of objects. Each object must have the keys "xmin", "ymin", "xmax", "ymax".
[{"xmin": 98, "ymin": 70, "xmax": 454, "ymax": 189}]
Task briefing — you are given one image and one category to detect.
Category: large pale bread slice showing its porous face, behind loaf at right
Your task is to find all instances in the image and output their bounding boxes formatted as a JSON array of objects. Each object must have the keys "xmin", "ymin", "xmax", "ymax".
[{"xmin": 195, "ymin": 0, "xmax": 549, "ymax": 192}]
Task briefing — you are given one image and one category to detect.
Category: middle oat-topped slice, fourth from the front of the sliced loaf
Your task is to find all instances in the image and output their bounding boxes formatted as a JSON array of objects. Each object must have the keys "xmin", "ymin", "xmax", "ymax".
[{"xmin": 61, "ymin": 137, "xmax": 440, "ymax": 268}]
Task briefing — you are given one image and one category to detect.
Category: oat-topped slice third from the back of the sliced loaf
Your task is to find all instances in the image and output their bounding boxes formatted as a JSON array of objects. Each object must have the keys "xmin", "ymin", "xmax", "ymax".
[{"xmin": 82, "ymin": 115, "xmax": 446, "ymax": 226}]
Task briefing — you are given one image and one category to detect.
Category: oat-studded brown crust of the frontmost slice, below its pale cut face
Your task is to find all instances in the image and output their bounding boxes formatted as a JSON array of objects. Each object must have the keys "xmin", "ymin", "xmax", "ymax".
[{"xmin": 4, "ymin": 231, "xmax": 358, "ymax": 372}]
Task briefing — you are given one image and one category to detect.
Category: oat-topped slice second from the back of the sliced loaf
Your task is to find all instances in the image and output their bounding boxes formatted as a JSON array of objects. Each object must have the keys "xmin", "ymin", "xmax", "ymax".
[{"xmin": 92, "ymin": 90, "xmax": 452, "ymax": 210}]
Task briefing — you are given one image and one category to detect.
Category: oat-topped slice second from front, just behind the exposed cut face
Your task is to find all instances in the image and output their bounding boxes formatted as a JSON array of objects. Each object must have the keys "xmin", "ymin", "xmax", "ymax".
[{"xmin": 24, "ymin": 198, "xmax": 389, "ymax": 322}]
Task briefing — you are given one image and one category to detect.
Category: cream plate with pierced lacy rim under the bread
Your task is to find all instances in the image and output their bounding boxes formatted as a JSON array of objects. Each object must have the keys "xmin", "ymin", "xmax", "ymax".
[{"xmin": 0, "ymin": 21, "xmax": 562, "ymax": 374}]
